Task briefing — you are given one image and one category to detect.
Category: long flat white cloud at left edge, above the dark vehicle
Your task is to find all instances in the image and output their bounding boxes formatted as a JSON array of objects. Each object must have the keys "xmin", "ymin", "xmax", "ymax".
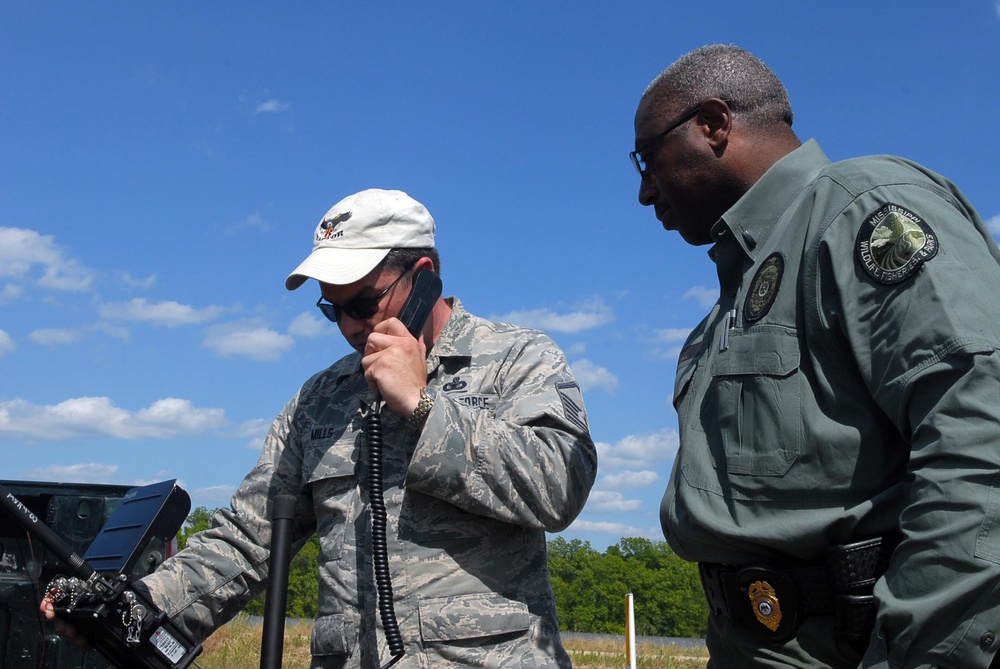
[{"xmin": 0, "ymin": 397, "xmax": 226, "ymax": 440}]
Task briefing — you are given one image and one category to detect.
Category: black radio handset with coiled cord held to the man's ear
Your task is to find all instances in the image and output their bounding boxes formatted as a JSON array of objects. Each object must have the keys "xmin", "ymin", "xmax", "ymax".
[{"xmin": 365, "ymin": 269, "xmax": 441, "ymax": 669}]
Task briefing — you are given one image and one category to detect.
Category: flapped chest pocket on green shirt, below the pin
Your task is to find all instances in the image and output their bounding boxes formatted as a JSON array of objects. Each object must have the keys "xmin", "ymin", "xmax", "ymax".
[{"xmin": 702, "ymin": 330, "xmax": 802, "ymax": 476}]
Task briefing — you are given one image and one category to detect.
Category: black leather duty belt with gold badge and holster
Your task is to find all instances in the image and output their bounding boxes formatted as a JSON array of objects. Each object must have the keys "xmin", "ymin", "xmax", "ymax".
[{"xmin": 698, "ymin": 537, "xmax": 898, "ymax": 641}]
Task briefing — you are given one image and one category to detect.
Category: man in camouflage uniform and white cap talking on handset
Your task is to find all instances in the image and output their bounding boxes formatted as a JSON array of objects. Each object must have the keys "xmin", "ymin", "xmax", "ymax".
[{"xmin": 43, "ymin": 189, "xmax": 597, "ymax": 669}]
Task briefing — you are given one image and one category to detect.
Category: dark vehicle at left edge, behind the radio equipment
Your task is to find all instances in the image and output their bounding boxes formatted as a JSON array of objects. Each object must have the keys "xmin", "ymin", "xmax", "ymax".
[{"xmin": 0, "ymin": 481, "xmax": 176, "ymax": 669}]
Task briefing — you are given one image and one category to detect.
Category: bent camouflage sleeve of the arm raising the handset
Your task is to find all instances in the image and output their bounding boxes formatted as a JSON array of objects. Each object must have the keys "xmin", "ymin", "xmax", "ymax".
[{"xmin": 405, "ymin": 333, "xmax": 597, "ymax": 532}]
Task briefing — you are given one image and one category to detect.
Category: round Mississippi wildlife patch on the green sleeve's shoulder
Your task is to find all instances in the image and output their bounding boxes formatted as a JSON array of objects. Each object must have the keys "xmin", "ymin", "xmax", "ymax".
[{"xmin": 855, "ymin": 203, "xmax": 938, "ymax": 286}]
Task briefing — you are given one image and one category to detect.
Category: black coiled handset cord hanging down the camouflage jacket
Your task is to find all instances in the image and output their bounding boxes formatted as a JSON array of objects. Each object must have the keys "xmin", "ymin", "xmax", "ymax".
[{"xmin": 365, "ymin": 400, "xmax": 405, "ymax": 669}]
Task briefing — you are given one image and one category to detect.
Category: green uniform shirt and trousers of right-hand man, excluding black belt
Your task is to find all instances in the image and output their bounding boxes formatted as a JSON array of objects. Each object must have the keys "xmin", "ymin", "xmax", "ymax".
[{"xmin": 661, "ymin": 141, "xmax": 1000, "ymax": 668}]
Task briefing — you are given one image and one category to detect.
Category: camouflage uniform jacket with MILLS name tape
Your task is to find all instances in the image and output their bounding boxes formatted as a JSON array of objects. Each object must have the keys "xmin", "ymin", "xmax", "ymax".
[{"xmin": 137, "ymin": 298, "xmax": 597, "ymax": 668}]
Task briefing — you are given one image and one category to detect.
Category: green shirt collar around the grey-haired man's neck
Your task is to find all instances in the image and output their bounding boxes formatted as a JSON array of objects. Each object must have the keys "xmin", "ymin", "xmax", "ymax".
[{"xmin": 712, "ymin": 139, "xmax": 830, "ymax": 260}]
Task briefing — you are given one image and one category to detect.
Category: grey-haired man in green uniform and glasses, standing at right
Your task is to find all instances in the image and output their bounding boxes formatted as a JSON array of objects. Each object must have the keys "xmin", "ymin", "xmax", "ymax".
[{"xmin": 631, "ymin": 45, "xmax": 1000, "ymax": 668}]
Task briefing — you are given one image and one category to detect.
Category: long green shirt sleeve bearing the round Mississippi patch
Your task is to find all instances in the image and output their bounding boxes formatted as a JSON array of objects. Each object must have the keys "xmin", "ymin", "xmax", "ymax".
[{"xmin": 820, "ymin": 180, "xmax": 1000, "ymax": 667}]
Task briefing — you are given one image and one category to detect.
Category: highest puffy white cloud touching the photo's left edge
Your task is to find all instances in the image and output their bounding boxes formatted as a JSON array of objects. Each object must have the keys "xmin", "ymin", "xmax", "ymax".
[{"xmin": 0, "ymin": 227, "xmax": 94, "ymax": 292}]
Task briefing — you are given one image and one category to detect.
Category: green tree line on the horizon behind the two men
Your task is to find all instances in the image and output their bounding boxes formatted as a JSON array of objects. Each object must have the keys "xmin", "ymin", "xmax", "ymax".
[{"xmin": 177, "ymin": 506, "xmax": 708, "ymax": 637}]
